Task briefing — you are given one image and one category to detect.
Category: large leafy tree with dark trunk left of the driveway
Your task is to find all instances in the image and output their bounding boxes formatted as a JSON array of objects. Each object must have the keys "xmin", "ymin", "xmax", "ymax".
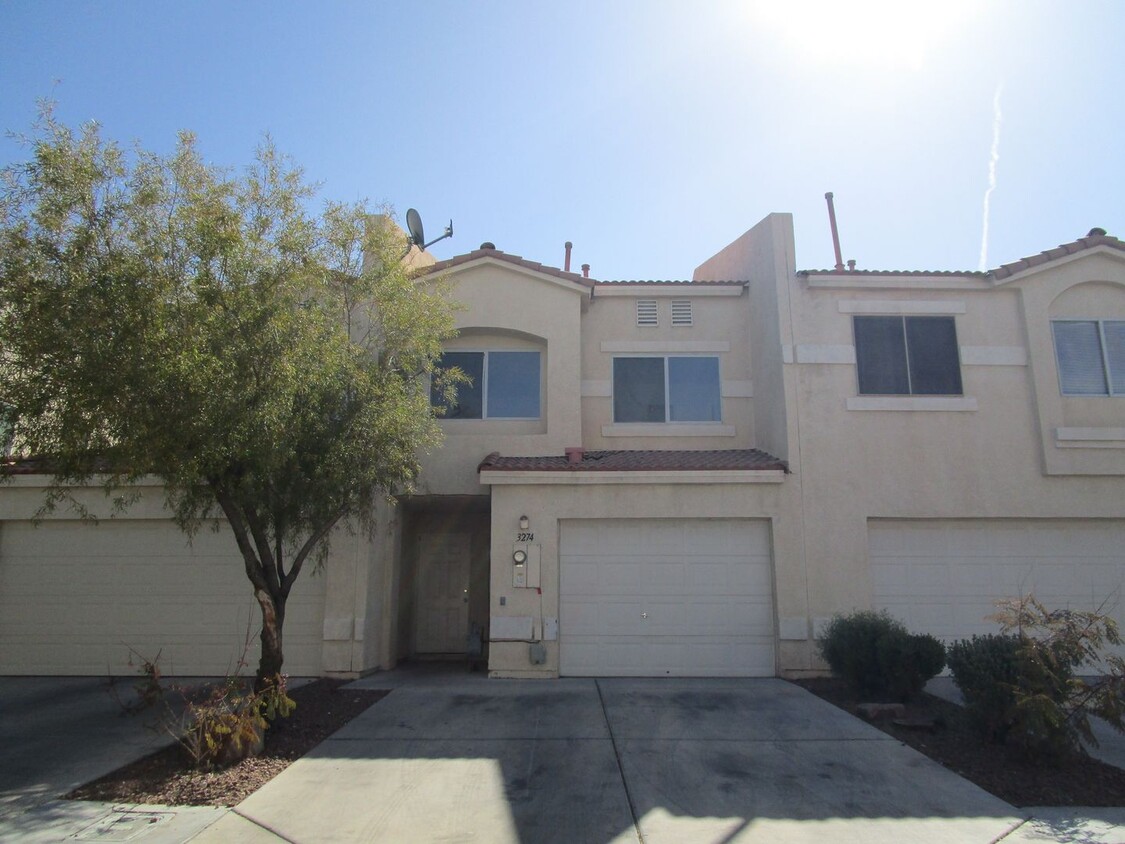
[{"xmin": 0, "ymin": 107, "xmax": 452, "ymax": 685}]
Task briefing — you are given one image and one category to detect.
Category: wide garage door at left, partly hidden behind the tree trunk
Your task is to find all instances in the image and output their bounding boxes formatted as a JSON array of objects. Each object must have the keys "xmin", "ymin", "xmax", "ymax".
[{"xmin": 0, "ymin": 519, "xmax": 324, "ymax": 675}]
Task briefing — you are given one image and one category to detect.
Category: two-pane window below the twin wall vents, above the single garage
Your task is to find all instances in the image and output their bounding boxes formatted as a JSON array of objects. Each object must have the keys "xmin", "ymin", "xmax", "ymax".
[{"xmin": 613, "ymin": 356, "xmax": 722, "ymax": 422}]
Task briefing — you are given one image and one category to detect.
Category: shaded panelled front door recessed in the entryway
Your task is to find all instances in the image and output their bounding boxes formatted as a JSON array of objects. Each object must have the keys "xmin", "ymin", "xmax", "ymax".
[{"xmin": 415, "ymin": 532, "xmax": 473, "ymax": 654}]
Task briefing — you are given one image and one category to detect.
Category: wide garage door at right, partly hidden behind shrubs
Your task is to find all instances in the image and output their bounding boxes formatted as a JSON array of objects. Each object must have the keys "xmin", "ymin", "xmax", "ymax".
[{"xmin": 867, "ymin": 519, "xmax": 1125, "ymax": 641}]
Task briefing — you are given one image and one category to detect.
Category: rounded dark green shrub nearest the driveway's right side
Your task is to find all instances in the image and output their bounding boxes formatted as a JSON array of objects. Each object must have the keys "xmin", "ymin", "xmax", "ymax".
[{"xmin": 819, "ymin": 610, "xmax": 945, "ymax": 700}]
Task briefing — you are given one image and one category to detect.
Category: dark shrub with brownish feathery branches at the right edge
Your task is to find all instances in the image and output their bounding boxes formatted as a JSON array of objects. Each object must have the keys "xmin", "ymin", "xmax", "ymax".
[{"xmin": 950, "ymin": 595, "xmax": 1125, "ymax": 762}]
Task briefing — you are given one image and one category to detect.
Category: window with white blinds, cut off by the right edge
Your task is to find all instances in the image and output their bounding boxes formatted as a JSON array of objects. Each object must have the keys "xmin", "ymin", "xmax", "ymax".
[{"xmin": 1051, "ymin": 320, "xmax": 1125, "ymax": 396}]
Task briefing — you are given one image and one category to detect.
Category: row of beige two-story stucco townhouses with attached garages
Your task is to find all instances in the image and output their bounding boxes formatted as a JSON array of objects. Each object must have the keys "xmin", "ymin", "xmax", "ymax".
[{"xmin": 0, "ymin": 214, "xmax": 1125, "ymax": 676}]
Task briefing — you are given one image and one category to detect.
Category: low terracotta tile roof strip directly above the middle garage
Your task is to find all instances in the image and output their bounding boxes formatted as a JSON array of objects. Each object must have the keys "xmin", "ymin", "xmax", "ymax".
[{"xmin": 477, "ymin": 448, "xmax": 789, "ymax": 473}]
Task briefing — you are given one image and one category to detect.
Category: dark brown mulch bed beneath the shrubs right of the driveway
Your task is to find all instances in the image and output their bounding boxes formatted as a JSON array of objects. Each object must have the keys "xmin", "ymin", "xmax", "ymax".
[{"xmin": 794, "ymin": 677, "xmax": 1125, "ymax": 807}]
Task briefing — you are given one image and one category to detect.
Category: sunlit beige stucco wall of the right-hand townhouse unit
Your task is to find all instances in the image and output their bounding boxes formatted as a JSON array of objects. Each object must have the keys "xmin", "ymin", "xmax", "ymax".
[{"xmin": 786, "ymin": 247, "xmax": 1125, "ymax": 643}]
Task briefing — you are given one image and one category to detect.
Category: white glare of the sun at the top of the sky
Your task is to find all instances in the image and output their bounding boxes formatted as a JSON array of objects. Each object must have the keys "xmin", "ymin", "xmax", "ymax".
[{"xmin": 749, "ymin": 0, "xmax": 975, "ymax": 70}]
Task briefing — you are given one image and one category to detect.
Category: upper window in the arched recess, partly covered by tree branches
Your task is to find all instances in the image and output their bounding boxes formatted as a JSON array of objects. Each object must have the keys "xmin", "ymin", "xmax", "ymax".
[{"xmin": 430, "ymin": 351, "xmax": 540, "ymax": 419}]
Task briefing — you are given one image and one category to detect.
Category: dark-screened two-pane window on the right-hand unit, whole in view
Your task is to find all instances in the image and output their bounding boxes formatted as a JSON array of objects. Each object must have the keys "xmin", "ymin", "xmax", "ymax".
[{"xmin": 853, "ymin": 316, "xmax": 962, "ymax": 396}]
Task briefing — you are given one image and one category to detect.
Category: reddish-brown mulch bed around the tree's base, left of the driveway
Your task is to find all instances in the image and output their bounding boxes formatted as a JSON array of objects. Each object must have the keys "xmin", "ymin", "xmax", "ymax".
[{"xmin": 66, "ymin": 679, "xmax": 387, "ymax": 806}]
